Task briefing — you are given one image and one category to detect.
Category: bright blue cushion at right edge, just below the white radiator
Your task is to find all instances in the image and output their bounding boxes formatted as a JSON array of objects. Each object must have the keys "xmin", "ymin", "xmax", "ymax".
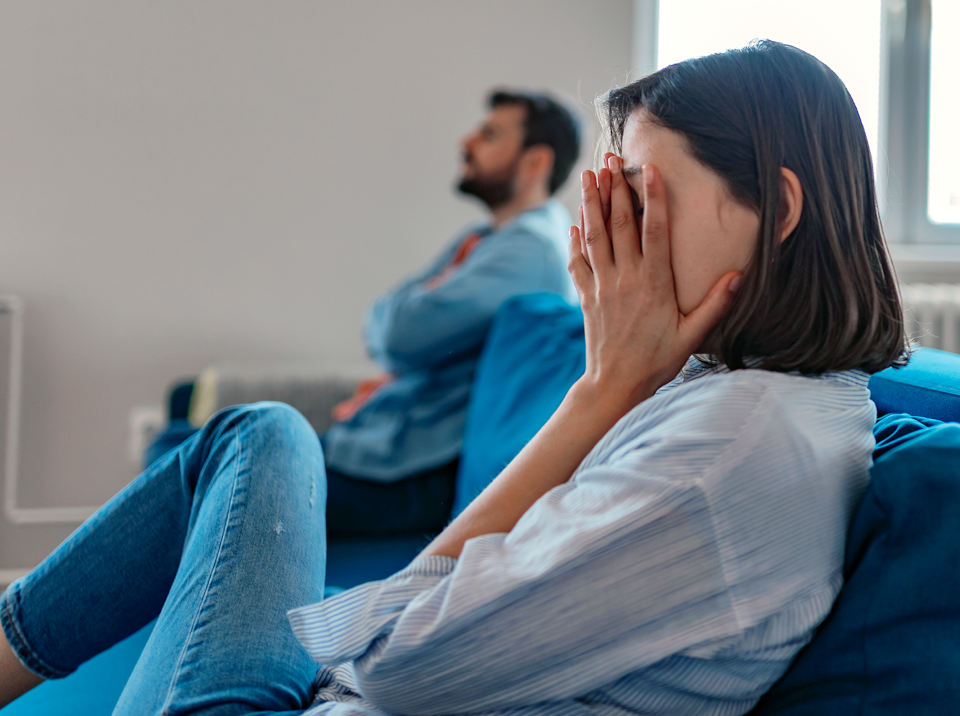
[{"xmin": 870, "ymin": 348, "xmax": 960, "ymax": 422}]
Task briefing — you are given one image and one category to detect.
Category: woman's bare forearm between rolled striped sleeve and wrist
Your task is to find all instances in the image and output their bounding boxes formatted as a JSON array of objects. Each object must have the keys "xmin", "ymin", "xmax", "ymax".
[{"xmin": 423, "ymin": 379, "xmax": 656, "ymax": 558}]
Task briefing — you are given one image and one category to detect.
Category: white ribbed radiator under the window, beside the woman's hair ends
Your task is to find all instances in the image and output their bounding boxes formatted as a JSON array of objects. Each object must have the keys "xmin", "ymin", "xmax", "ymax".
[{"xmin": 901, "ymin": 283, "xmax": 960, "ymax": 353}]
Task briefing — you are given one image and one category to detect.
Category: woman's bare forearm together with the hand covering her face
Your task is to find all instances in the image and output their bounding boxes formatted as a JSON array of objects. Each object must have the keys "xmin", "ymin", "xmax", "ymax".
[{"xmin": 423, "ymin": 155, "xmax": 739, "ymax": 558}]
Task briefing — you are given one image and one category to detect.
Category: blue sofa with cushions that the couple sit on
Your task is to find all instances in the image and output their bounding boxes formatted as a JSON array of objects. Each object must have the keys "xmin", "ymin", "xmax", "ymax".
[{"xmin": 0, "ymin": 295, "xmax": 960, "ymax": 716}]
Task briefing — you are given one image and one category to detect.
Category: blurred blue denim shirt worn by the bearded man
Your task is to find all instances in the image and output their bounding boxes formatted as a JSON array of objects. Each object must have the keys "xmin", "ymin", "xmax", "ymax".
[{"xmin": 324, "ymin": 200, "xmax": 575, "ymax": 482}]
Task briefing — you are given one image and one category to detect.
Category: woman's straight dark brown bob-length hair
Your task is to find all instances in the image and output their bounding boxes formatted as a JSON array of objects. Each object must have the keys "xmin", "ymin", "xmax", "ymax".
[{"xmin": 601, "ymin": 40, "xmax": 909, "ymax": 373}]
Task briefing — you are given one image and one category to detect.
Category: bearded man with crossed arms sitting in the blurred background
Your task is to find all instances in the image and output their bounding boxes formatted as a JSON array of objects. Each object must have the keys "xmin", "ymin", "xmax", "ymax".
[{"xmin": 148, "ymin": 91, "xmax": 579, "ymax": 536}]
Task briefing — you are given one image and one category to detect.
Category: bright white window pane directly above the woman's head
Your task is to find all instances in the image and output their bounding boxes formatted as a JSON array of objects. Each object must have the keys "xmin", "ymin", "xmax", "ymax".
[{"xmin": 657, "ymin": 0, "xmax": 880, "ymax": 178}]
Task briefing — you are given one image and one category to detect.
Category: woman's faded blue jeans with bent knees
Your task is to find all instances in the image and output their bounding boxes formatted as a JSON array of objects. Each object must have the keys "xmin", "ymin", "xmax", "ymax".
[{"xmin": 0, "ymin": 403, "xmax": 327, "ymax": 716}]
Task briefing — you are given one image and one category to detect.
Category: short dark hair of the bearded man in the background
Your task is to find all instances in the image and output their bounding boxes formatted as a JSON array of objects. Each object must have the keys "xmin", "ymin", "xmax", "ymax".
[{"xmin": 487, "ymin": 89, "xmax": 580, "ymax": 194}]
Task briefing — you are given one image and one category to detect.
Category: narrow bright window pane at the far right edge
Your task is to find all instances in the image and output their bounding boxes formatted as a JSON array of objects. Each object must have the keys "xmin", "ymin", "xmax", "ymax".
[{"xmin": 927, "ymin": 0, "xmax": 960, "ymax": 224}]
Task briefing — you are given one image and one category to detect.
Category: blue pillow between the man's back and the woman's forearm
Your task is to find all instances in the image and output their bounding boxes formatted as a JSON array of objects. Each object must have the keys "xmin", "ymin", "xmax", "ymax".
[{"xmin": 453, "ymin": 293, "xmax": 586, "ymax": 516}]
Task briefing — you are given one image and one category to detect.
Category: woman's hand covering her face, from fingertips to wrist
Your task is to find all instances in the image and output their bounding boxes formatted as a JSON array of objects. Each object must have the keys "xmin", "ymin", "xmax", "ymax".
[{"xmin": 569, "ymin": 155, "xmax": 740, "ymax": 416}]
